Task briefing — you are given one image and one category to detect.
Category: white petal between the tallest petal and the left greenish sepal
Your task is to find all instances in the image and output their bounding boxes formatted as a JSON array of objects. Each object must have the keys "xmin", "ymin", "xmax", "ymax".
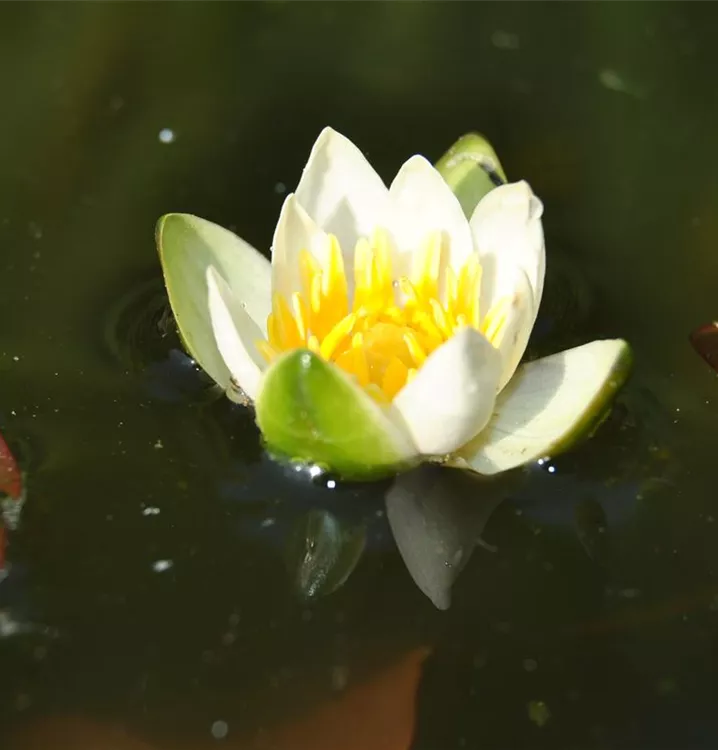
[{"xmin": 272, "ymin": 193, "xmax": 328, "ymax": 301}]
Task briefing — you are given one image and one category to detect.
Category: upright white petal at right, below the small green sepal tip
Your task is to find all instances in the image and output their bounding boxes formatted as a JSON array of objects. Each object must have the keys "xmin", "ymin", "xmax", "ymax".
[{"xmin": 470, "ymin": 182, "xmax": 546, "ymax": 323}]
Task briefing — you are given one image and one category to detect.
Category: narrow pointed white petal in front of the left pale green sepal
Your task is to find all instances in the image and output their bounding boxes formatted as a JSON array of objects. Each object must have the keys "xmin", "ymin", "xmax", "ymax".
[{"xmin": 207, "ymin": 266, "xmax": 266, "ymax": 399}]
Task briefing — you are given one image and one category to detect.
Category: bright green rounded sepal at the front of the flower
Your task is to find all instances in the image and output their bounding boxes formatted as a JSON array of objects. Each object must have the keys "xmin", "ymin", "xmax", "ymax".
[{"xmin": 256, "ymin": 349, "xmax": 416, "ymax": 480}]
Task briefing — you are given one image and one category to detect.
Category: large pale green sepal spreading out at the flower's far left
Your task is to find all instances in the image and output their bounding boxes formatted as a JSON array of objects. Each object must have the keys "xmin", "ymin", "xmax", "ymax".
[{"xmin": 156, "ymin": 214, "xmax": 271, "ymax": 389}]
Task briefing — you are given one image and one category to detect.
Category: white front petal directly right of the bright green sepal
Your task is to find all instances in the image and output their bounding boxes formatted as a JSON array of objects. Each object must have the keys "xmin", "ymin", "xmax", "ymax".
[{"xmin": 393, "ymin": 328, "xmax": 501, "ymax": 455}]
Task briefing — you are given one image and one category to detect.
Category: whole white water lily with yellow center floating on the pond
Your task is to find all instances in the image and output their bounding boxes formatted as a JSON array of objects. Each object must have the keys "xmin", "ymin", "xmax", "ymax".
[{"xmin": 157, "ymin": 128, "xmax": 629, "ymax": 478}]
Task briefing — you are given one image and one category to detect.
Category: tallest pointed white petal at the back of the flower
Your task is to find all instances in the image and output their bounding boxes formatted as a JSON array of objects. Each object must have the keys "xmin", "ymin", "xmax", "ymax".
[{"xmin": 296, "ymin": 128, "xmax": 389, "ymax": 251}]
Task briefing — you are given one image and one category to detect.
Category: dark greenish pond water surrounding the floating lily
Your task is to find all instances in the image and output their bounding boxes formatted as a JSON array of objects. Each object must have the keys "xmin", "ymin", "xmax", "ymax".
[{"xmin": 0, "ymin": 0, "xmax": 718, "ymax": 750}]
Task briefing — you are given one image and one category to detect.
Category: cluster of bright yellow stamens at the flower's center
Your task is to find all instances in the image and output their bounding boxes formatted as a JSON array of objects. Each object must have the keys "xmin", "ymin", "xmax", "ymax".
[{"xmin": 257, "ymin": 230, "xmax": 510, "ymax": 401}]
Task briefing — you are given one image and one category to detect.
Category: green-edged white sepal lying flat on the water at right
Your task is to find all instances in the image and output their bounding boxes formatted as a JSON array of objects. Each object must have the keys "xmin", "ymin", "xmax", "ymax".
[{"xmin": 455, "ymin": 339, "xmax": 631, "ymax": 474}]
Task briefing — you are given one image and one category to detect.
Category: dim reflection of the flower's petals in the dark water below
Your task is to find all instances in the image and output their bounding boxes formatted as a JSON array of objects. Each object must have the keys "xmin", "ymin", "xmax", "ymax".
[{"xmin": 272, "ymin": 465, "xmax": 517, "ymax": 609}]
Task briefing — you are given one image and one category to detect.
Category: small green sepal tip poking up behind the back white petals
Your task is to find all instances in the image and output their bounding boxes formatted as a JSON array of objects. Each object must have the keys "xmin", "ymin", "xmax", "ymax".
[{"xmin": 436, "ymin": 133, "xmax": 506, "ymax": 218}]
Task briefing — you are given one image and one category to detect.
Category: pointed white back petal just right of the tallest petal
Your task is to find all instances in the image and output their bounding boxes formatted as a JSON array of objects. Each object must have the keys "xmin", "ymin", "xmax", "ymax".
[{"xmin": 389, "ymin": 156, "xmax": 474, "ymax": 271}]
